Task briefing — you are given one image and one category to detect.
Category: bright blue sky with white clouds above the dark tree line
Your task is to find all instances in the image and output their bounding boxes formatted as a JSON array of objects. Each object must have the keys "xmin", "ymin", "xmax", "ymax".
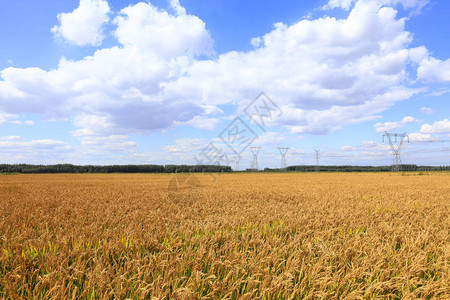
[{"xmin": 0, "ymin": 0, "xmax": 450, "ymax": 168}]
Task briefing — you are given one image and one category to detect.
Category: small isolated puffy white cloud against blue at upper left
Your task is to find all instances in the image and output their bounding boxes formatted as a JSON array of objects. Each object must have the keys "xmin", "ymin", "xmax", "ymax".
[{"xmin": 51, "ymin": 0, "xmax": 110, "ymax": 46}]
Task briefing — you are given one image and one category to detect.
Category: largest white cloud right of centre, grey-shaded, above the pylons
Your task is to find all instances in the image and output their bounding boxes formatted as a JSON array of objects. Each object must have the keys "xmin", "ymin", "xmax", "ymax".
[{"xmin": 164, "ymin": 1, "xmax": 421, "ymax": 133}]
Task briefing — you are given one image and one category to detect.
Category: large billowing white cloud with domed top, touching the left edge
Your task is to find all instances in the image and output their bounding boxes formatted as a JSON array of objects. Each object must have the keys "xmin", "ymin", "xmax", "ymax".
[{"xmin": 0, "ymin": 2, "xmax": 212, "ymax": 136}]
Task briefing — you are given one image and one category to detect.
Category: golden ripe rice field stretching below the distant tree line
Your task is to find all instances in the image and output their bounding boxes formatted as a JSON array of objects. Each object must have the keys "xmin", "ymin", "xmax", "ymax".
[{"xmin": 0, "ymin": 172, "xmax": 450, "ymax": 299}]
